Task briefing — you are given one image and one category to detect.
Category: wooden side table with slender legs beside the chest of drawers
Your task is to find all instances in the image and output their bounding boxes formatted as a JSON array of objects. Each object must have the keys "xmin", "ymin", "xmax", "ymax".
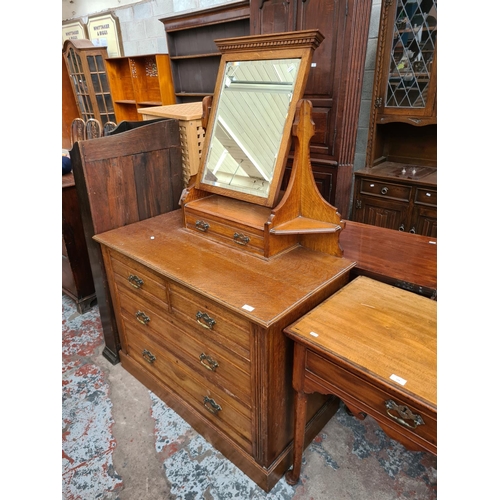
[{"xmin": 284, "ymin": 276, "xmax": 437, "ymax": 484}]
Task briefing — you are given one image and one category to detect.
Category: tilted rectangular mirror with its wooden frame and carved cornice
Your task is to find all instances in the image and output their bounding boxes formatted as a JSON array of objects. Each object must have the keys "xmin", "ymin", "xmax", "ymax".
[{"xmin": 196, "ymin": 30, "xmax": 322, "ymax": 206}]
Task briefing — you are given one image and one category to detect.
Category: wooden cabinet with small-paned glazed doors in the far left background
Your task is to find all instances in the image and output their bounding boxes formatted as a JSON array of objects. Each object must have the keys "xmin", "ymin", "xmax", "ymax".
[{"xmin": 63, "ymin": 40, "xmax": 116, "ymax": 126}]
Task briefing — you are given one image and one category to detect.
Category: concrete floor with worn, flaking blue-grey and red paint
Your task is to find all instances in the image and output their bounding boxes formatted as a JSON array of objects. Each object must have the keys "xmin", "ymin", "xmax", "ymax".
[{"xmin": 62, "ymin": 295, "xmax": 437, "ymax": 500}]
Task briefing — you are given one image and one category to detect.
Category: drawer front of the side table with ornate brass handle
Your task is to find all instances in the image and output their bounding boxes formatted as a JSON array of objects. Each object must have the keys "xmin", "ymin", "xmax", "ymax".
[{"xmin": 306, "ymin": 351, "xmax": 437, "ymax": 446}]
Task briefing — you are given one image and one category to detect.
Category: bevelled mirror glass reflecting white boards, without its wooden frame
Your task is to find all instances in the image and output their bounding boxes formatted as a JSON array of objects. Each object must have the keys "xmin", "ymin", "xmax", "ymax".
[{"xmin": 203, "ymin": 59, "xmax": 300, "ymax": 198}]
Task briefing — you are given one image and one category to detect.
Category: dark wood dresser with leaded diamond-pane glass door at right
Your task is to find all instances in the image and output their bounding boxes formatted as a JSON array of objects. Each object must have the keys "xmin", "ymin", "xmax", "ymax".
[{"xmin": 351, "ymin": 0, "xmax": 437, "ymax": 238}]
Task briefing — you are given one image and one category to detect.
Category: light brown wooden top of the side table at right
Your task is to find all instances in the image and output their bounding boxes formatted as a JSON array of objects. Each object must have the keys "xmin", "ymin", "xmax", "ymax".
[{"xmin": 285, "ymin": 276, "xmax": 437, "ymax": 408}]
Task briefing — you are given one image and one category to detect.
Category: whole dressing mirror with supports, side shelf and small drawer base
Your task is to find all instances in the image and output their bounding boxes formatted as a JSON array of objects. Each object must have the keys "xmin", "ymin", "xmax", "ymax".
[{"xmin": 181, "ymin": 30, "xmax": 344, "ymax": 258}]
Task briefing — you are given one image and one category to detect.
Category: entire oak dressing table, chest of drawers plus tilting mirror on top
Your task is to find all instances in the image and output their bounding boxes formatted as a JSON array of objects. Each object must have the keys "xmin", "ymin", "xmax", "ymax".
[{"xmin": 94, "ymin": 30, "xmax": 355, "ymax": 491}]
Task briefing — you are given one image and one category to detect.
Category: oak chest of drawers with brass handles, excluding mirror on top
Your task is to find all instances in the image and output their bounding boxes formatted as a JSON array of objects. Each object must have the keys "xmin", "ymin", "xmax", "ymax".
[{"xmin": 94, "ymin": 210, "xmax": 354, "ymax": 491}]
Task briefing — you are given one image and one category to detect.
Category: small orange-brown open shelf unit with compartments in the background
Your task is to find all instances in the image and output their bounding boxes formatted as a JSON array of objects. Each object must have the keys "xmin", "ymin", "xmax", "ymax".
[{"xmin": 106, "ymin": 54, "xmax": 175, "ymax": 122}]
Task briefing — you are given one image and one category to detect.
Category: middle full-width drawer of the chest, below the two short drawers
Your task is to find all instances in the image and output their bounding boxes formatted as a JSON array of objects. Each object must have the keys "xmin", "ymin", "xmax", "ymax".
[{"xmin": 120, "ymin": 289, "xmax": 251, "ymax": 406}]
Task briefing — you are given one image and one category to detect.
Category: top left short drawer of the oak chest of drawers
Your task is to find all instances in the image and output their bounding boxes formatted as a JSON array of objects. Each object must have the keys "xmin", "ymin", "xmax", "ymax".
[{"xmin": 111, "ymin": 252, "xmax": 168, "ymax": 307}]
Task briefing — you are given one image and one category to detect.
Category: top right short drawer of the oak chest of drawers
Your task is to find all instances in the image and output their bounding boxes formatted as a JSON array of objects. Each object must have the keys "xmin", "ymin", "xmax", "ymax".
[{"xmin": 169, "ymin": 283, "xmax": 251, "ymax": 359}]
